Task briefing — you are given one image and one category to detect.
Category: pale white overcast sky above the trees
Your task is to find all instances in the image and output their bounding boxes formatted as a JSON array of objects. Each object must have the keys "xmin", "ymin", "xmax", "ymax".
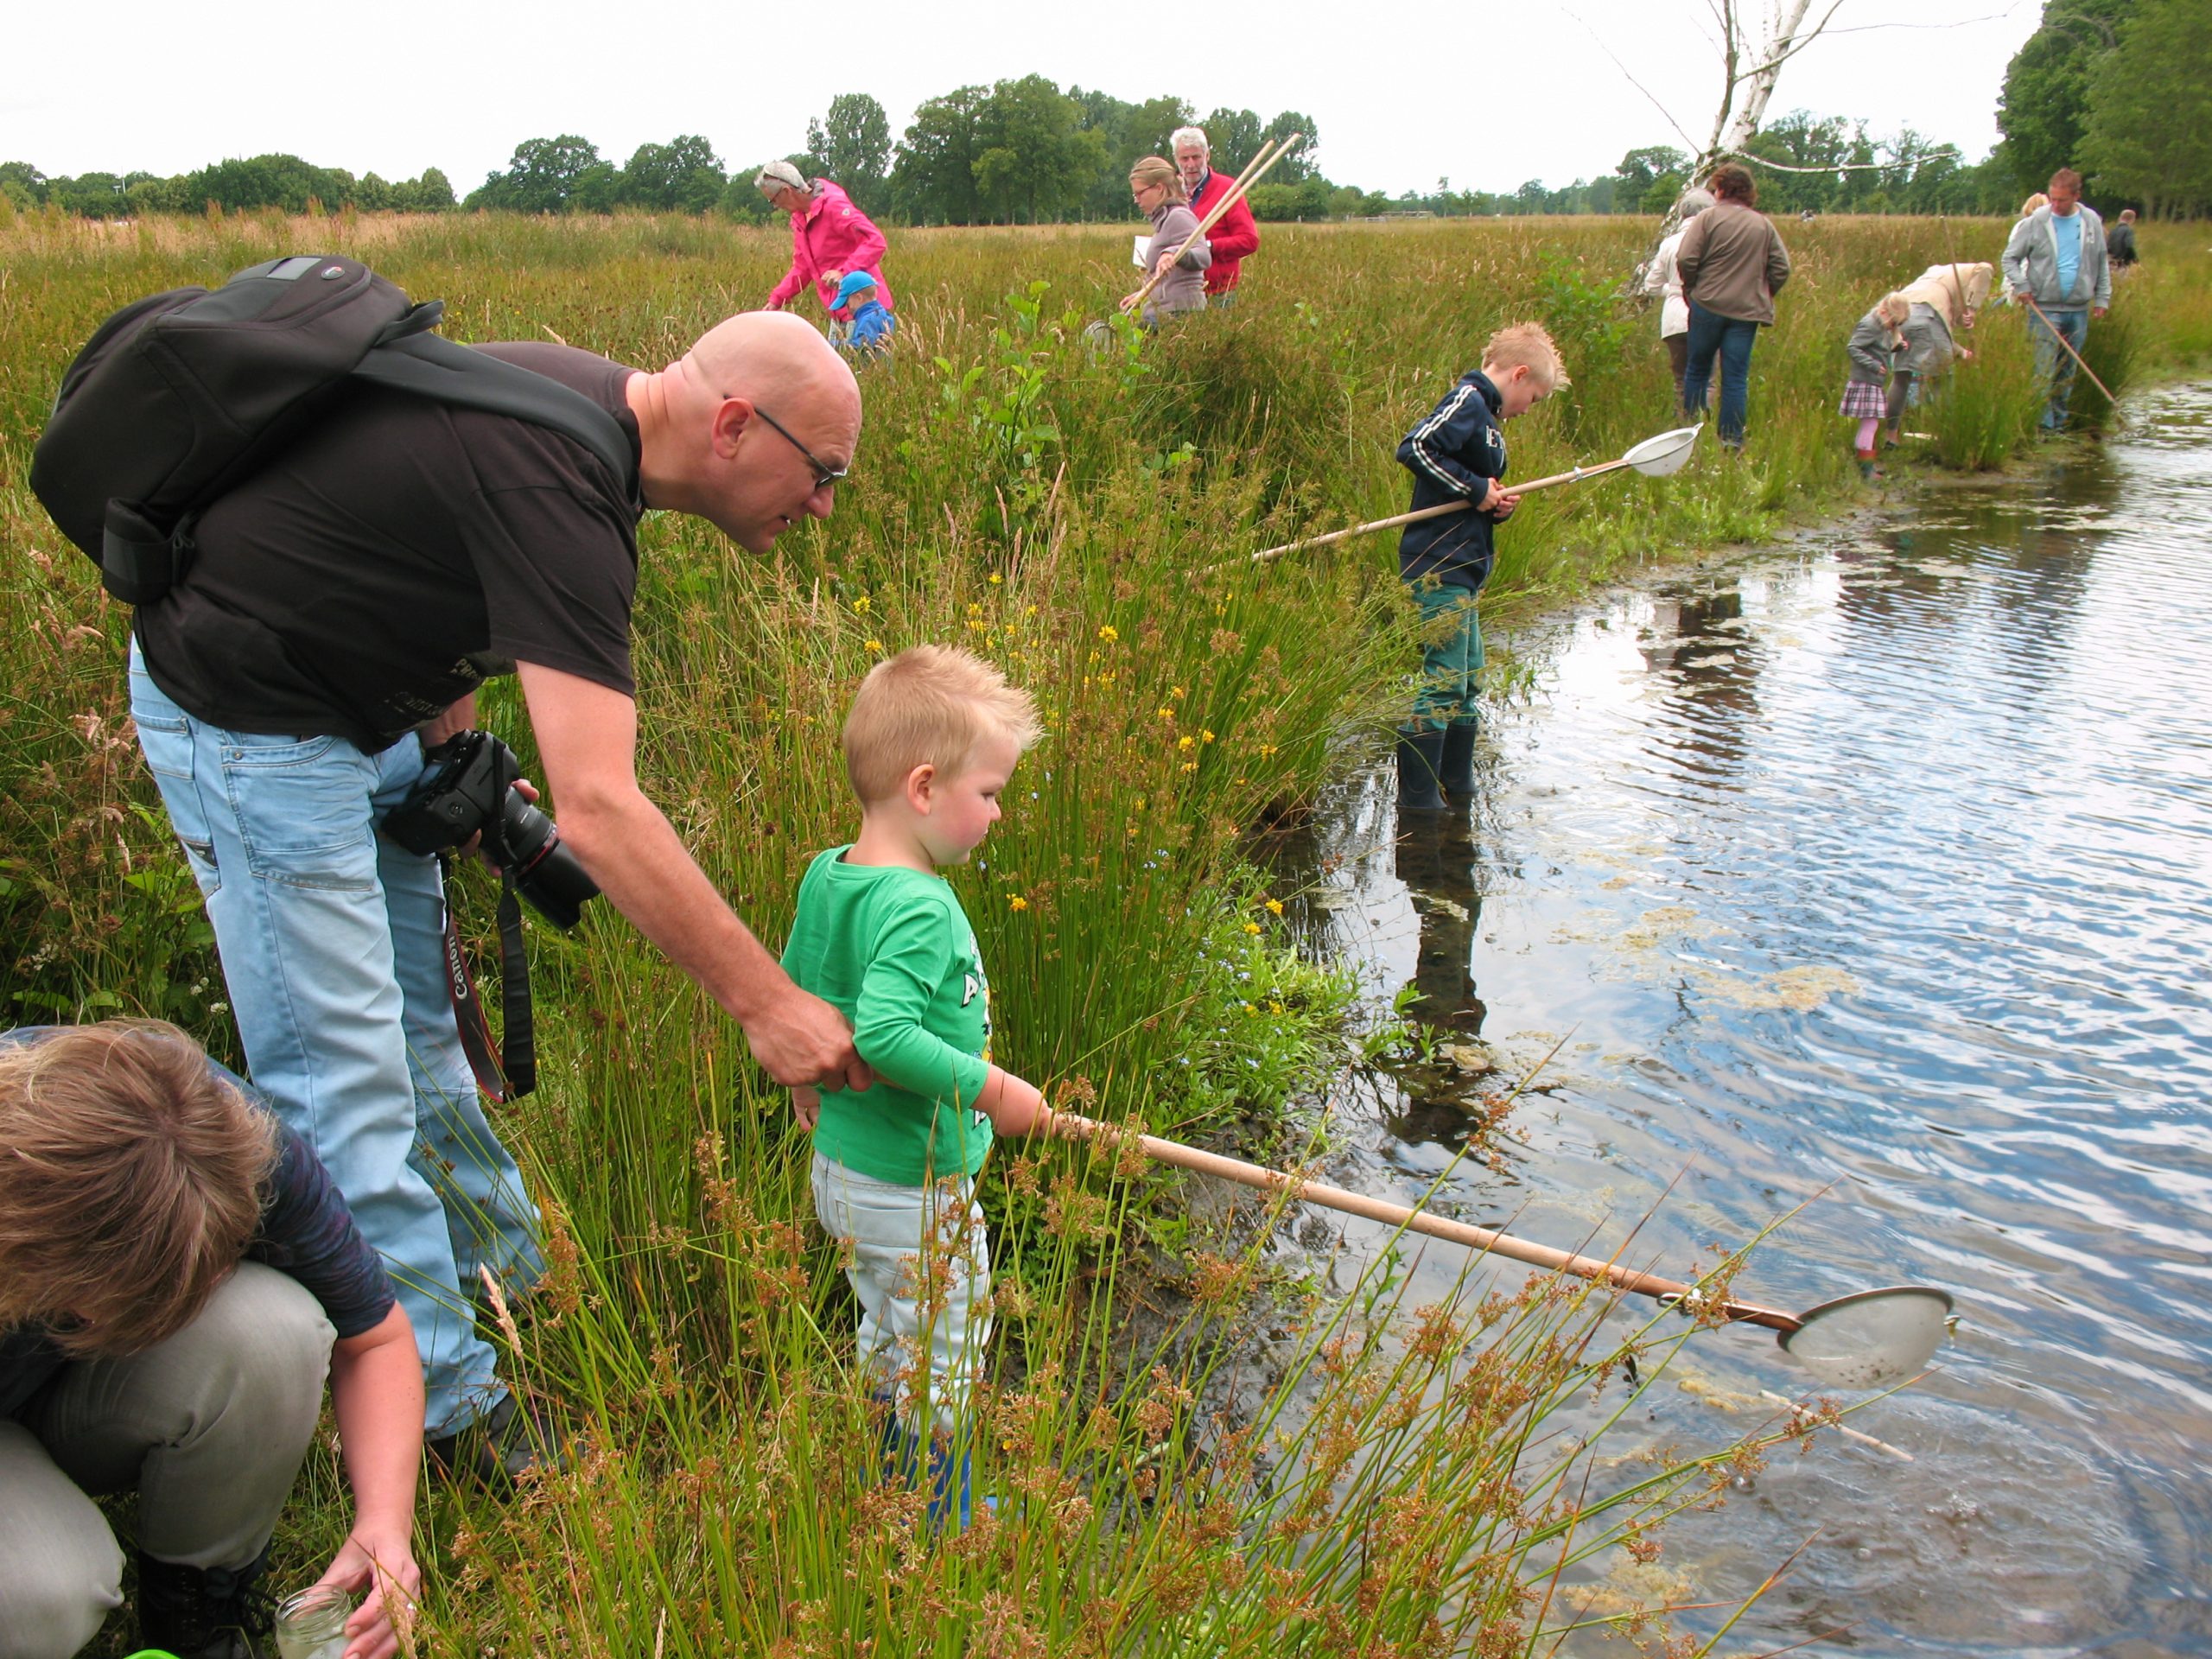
[{"xmin": 0, "ymin": 0, "xmax": 2042, "ymax": 194}]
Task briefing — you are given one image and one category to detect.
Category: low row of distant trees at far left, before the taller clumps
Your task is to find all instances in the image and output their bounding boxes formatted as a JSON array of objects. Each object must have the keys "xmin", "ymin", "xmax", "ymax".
[{"xmin": 0, "ymin": 155, "xmax": 455, "ymax": 219}]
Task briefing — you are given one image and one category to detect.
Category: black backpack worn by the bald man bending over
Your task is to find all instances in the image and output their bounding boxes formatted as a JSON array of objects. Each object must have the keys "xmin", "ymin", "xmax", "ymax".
[{"xmin": 31, "ymin": 257, "xmax": 637, "ymax": 604}]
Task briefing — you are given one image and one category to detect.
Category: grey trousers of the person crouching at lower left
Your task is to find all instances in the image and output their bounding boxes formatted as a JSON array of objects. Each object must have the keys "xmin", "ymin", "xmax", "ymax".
[{"xmin": 0, "ymin": 1261, "xmax": 334, "ymax": 1659}]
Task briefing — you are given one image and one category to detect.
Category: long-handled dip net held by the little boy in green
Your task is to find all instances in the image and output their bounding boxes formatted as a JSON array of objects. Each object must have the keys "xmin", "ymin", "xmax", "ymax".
[{"xmin": 1044, "ymin": 1110, "xmax": 1951, "ymax": 1387}]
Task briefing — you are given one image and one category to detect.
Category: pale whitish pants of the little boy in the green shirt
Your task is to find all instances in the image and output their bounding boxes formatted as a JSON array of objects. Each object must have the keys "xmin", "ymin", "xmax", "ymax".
[{"xmin": 814, "ymin": 1153, "xmax": 991, "ymax": 1433}]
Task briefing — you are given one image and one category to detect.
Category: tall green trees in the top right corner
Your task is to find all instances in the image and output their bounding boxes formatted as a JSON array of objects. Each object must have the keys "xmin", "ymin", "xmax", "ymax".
[{"xmin": 1998, "ymin": 0, "xmax": 2212, "ymax": 219}]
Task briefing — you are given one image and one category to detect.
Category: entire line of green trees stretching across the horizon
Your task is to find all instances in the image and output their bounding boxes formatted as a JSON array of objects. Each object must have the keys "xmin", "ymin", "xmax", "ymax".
[{"xmin": 13, "ymin": 37, "xmax": 2212, "ymax": 226}]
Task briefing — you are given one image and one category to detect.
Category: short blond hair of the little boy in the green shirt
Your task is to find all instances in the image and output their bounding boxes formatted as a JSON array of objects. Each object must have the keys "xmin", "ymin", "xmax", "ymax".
[{"xmin": 845, "ymin": 646, "xmax": 1044, "ymax": 805}]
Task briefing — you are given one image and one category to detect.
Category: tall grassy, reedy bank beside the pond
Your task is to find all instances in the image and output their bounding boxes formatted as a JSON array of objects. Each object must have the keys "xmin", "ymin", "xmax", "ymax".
[{"xmin": 0, "ymin": 219, "xmax": 2212, "ymax": 1655}]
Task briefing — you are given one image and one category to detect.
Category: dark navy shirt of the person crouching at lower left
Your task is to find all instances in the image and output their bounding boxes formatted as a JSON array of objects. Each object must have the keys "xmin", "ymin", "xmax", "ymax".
[{"xmin": 0, "ymin": 1027, "xmax": 396, "ymax": 1418}]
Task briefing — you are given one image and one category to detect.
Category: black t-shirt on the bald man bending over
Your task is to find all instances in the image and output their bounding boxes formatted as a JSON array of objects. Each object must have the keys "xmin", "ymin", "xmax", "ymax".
[{"xmin": 137, "ymin": 343, "xmax": 644, "ymax": 752}]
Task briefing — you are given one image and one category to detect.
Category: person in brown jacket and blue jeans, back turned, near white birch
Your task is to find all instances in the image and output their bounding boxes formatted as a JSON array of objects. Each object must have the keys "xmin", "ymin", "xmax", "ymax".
[{"xmin": 1675, "ymin": 162, "xmax": 1789, "ymax": 449}]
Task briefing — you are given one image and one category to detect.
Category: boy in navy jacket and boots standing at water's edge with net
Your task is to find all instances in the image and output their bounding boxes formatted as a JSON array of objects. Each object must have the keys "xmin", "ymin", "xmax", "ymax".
[{"xmin": 1398, "ymin": 323, "xmax": 1568, "ymax": 812}]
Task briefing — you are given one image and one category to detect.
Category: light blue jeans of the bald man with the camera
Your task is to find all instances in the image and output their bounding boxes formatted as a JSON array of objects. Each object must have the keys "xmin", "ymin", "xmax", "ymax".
[{"xmin": 130, "ymin": 644, "xmax": 544, "ymax": 1435}]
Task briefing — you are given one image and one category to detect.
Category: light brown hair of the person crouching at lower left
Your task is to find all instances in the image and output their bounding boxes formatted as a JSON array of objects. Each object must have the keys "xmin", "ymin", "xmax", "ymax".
[{"xmin": 0, "ymin": 1020, "xmax": 276, "ymax": 1356}]
